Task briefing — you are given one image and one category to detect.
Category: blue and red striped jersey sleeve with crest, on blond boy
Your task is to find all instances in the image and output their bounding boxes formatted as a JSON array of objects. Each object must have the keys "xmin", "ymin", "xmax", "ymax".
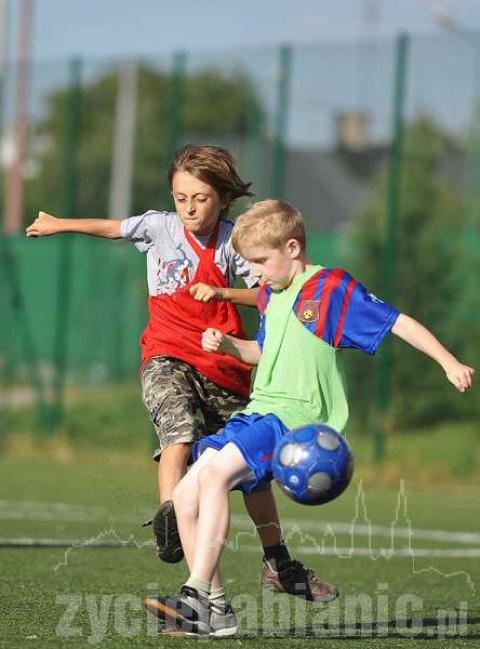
[{"xmin": 294, "ymin": 268, "xmax": 400, "ymax": 354}]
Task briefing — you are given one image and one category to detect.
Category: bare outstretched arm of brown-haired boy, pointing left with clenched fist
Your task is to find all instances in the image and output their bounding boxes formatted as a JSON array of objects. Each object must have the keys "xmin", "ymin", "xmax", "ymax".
[{"xmin": 25, "ymin": 212, "xmax": 122, "ymax": 239}]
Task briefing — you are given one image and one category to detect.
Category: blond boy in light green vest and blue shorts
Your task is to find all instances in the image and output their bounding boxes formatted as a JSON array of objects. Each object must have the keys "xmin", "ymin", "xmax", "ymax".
[{"xmin": 145, "ymin": 200, "xmax": 475, "ymax": 635}]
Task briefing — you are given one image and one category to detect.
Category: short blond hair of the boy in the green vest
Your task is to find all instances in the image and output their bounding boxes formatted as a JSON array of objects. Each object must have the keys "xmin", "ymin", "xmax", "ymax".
[{"xmin": 232, "ymin": 198, "xmax": 306, "ymax": 254}]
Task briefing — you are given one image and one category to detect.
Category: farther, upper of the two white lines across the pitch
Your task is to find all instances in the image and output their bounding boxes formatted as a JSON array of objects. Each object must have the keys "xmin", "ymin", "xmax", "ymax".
[{"xmin": 0, "ymin": 500, "xmax": 480, "ymax": 545}]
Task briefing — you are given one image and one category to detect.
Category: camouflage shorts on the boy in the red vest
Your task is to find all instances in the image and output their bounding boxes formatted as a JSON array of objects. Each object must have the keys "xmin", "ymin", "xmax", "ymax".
[{"xmin": 141, "ymin": 356, "xmax": 248, "ymax": 460}]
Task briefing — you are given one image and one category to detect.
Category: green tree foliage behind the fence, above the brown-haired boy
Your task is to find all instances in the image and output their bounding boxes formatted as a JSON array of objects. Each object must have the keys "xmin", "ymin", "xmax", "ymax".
[{"xmin": 26, "ymin": 66, "xmax": 263, "ymax": 221}]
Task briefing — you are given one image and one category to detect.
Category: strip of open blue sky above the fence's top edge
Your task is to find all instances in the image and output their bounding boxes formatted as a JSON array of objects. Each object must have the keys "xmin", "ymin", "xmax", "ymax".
[{"xmin": 10, "ymin": 0, "xmax": 480, "ymax": 60}]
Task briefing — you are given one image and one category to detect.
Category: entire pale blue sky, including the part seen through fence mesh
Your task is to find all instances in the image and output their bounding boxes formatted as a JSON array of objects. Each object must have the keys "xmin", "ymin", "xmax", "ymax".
[{"xmin": 7, "ymin": 0, "xmax": 480, "ymax": 148}]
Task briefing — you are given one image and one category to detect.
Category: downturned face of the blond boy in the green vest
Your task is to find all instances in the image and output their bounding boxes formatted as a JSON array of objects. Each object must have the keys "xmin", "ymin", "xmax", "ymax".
[{"xmin": 242, "ymin": 239, "xmax": 303, "ymax": 291}]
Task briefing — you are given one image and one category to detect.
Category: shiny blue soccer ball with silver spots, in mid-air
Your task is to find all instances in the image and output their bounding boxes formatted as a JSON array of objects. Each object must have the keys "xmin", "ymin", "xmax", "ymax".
[{"xmin": 272, "ymin": 424, "xmax": 354, "ymax": 505}]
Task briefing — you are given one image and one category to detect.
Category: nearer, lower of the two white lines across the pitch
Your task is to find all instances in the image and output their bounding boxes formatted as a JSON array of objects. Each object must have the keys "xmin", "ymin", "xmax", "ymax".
[{"xmin": 0, "ymin": 538, "xmax": 480, "ymax": 559}]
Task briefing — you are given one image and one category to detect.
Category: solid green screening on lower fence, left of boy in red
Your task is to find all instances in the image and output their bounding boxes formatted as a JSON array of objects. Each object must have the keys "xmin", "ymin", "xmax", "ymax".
[{"xmin": 0, "ymin": 234, "xmax": 344, "ymax": 385}]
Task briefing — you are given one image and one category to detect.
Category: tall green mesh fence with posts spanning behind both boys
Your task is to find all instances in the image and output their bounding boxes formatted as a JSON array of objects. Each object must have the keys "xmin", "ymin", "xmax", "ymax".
[{"xmin": 0, "ymin": 33, "xmax": 480, "ymax": 446}]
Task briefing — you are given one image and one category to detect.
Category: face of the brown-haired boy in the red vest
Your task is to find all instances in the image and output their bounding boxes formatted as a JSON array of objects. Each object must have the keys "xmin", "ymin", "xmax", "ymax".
[{"xmin": 172, "ymin": 171, "xmax": 226, "ymax": 235}]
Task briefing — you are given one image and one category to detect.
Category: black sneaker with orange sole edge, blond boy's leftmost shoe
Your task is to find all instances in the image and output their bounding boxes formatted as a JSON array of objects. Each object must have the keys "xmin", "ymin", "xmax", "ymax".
[{"xmin": 144, "ymin": 586, "xmax": 211, "ymax": 636}]
